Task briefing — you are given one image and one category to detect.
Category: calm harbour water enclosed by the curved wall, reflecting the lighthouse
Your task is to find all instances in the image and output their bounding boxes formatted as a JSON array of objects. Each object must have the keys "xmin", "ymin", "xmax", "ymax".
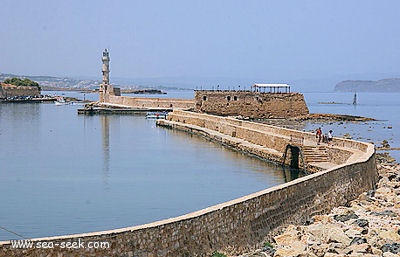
[{"xmin": 0, "ymin": 93, "xmax": 295, "ymax": 240}]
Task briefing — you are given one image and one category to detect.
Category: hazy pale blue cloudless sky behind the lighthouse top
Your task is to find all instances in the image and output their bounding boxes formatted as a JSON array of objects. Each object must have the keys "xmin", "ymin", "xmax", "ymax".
[{"xmin": 0, "ymin": 0, "xmax": 400, "ymax": 80}]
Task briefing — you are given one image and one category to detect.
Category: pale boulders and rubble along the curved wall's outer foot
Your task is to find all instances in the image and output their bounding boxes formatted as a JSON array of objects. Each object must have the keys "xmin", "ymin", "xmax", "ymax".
[{"xmin": 236, "ymin": 154, "xmax": 400, "ymax": 257}]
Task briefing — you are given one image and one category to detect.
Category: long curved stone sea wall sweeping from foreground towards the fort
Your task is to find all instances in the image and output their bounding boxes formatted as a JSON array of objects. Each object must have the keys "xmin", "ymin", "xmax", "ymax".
[{"xmin": 0, "ymin": 111, "xmax": 377, "ymax": 257}]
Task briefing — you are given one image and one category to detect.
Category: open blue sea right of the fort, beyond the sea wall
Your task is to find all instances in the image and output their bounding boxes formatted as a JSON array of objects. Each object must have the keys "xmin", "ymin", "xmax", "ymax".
[{"xmin": 304, "ymin": 92, "xmax": 400, "ymax": 162}]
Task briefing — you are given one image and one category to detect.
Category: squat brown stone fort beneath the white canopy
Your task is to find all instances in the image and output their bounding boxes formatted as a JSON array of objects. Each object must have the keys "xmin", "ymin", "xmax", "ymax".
[{"xmin": 195, "ymin": 90, "xmax": 309, "ymax": 118}]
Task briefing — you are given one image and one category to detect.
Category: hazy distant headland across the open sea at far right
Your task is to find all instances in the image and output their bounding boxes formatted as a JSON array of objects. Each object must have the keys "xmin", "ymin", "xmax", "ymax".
[{"xmin": 335, "ymin": 78, "xmax": 400, "ymax": 92}]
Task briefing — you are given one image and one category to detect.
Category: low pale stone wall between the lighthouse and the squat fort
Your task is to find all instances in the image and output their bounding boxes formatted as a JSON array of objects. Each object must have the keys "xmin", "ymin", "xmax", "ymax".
[{"xmin": 104, "ymin": 94, "xmax": 194, "ymax": 109}]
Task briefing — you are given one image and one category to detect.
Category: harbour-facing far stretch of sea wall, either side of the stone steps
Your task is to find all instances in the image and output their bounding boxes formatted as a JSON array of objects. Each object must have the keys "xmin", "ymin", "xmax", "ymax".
[{"xmin": 163, "ymin": 110, "xmax": 373, "ymax": 171}]
